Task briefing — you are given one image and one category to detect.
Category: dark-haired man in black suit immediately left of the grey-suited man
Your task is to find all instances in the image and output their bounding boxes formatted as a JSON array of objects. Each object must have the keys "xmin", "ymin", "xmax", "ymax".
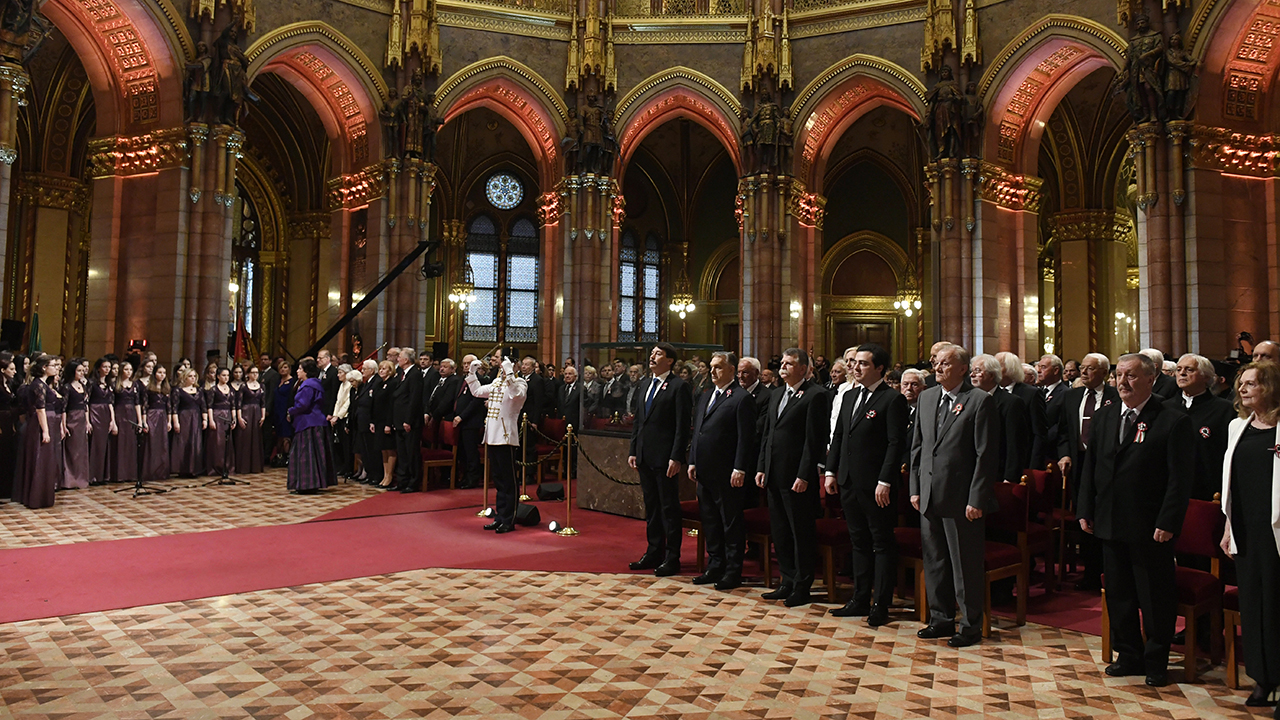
[{"xmin": 826, "ymin": 343, "xmax": 910, "ymax": 628}]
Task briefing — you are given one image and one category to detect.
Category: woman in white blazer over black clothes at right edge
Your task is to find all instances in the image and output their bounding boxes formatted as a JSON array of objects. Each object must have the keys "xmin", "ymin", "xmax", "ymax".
[{"xmin": 1222, "ymin": 361, "xmax": 1280, "ymax": 716}]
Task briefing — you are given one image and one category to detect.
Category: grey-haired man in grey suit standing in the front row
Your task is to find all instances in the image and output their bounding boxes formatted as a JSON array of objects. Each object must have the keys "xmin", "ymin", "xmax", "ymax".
[{"xmin": 910, "ymin": 345, "xmax": 1000, "ymax": 647}]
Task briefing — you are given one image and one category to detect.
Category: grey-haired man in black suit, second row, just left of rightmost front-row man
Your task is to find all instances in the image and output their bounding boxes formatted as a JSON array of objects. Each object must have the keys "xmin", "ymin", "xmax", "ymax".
[{"xmin": 1057, "ymin": 352, "xmax": 1120, "ymax": 592}]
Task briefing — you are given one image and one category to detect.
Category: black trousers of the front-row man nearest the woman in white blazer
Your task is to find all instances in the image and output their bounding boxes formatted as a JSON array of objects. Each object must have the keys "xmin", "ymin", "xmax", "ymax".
[{"xmin": 1102, "ymin": 539, "xmax": 1177, "ymax": 674}]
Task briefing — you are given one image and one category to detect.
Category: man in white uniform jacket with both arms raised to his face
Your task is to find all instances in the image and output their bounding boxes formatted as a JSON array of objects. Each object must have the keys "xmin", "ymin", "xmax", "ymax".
[{"xmin": 467, "ymin": 351, "xmax": 529, "ymax": 533}]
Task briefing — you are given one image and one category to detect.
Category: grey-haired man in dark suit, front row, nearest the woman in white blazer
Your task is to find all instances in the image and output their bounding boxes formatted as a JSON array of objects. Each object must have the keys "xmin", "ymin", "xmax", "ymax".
[{"xmin": 1078, "ymin": 354, "xmax": 1196, "ymax": 687}]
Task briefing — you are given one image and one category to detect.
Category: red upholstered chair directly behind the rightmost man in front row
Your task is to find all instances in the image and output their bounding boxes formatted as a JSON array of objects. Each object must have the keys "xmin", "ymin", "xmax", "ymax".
[{"xmin": 1102, "ymin": 493, "xmax": 1226, "ymax": 683}]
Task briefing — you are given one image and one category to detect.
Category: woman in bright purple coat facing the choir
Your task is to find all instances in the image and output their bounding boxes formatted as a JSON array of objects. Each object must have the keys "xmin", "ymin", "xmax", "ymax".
[{"xmin": 288, "ymin": 357, "xmax": 338, "ymax": 495}]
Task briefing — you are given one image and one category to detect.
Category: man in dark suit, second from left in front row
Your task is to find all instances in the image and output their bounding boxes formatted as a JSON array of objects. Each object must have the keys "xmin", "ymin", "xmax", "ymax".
[{"xmin": 689, "ymin": 352, "xmax": 758, "ymax": 591}]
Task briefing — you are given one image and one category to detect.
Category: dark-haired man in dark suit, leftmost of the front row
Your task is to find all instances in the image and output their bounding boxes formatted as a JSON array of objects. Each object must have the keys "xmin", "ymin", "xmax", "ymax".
[{"xmin": 627, "ymin": 342, "xmax": 692, "ymax": 578}]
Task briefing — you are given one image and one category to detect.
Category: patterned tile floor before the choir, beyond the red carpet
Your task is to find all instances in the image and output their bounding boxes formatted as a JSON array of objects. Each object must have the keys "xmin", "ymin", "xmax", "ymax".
[{"xmin": 0, "ymin": 469, "xmax": 384, "ymax": 548}]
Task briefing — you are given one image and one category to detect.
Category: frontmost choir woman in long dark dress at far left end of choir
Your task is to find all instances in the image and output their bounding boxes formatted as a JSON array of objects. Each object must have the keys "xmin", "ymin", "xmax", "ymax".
[{"xmin": 13, "ymin": 355, "xmax": 67, "ymax": 510}]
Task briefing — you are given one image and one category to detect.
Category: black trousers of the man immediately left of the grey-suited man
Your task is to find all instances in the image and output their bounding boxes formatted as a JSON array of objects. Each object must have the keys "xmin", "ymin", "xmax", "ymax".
[{"xmin": 840, "ymin": 483, "xmax": 897, "ymax": 609}]
